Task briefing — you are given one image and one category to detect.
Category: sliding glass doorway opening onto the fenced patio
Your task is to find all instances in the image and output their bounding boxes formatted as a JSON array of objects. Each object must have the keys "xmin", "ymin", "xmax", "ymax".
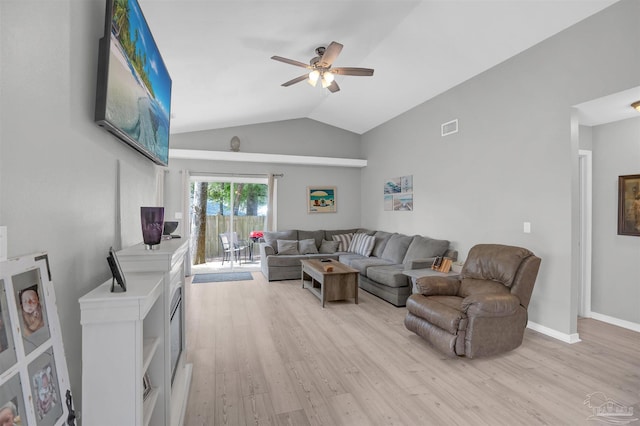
[{"xmin": 189, "ymin": 175, "xmax": 269, "ymax": 273}]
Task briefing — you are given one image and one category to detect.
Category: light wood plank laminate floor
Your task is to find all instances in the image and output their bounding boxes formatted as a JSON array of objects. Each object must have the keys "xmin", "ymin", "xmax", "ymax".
[{"xmin": 185, "ymin": 272, "xmax": 640, "ymax": 426}]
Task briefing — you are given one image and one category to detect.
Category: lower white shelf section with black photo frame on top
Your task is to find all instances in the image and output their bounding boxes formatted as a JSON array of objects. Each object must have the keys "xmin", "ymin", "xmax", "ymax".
[{"xmin": 80, "ymin": 273, "xmax": 167, "ymax": 426}]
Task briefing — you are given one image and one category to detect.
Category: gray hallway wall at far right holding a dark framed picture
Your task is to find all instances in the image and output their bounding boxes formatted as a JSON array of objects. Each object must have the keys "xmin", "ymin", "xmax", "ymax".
[{"xmin": 591, "ymin": 118, "xmax": 640, "ymax": 324}]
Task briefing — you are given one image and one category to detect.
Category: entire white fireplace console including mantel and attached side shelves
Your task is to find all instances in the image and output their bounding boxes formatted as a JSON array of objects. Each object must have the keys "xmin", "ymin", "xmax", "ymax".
[{"xmin": 80, "ymin": 239, "xmax": 192, "ymax": 426}]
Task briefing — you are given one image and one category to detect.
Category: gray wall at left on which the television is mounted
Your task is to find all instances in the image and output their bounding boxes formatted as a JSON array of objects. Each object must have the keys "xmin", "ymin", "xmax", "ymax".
[{"xmin": 0, "ymin": 0, "xmax": 156, "ymax": 410}]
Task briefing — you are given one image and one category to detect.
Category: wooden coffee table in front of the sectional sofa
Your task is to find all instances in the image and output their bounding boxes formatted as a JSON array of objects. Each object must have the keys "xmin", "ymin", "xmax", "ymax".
[{"xmin": 300, "ymin": 259, "xmax": 360, "ymax": 308}]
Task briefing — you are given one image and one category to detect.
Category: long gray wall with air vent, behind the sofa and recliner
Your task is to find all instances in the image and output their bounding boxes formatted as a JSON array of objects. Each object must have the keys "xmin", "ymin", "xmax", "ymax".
[{"xmin": 362, "ymin": 0, "xmax": 640, "ymax": 334}]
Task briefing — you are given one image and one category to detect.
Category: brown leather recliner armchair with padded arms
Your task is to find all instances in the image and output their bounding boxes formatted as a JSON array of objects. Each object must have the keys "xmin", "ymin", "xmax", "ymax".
[{"xmin": 404, "ymin": 244, "xmax": 541, "ymax": 358}]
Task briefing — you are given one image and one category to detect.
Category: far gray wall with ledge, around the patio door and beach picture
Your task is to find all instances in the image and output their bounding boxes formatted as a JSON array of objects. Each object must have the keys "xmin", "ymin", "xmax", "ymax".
[{"xmin": 165, "ymin": 119, "xmax": 361, "ymax": 232}]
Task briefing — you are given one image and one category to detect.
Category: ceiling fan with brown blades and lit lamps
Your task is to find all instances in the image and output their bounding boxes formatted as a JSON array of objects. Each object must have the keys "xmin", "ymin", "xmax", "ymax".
[{"xmin": 271, "ymin": 41, "xmax": 373, "ymax": 93}]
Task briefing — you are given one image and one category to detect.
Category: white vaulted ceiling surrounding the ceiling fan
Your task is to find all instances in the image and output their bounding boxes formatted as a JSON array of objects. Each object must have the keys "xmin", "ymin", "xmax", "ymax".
[{"xmin": 139, "ymin": 0, "xmax": 617, "ymax": 134}]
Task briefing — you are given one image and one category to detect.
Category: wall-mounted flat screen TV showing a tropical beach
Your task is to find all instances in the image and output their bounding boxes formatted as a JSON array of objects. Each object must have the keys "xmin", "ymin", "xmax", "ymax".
[{"xmin": 95, "ymin": 0, "xmax": 171, "ymax": 166}]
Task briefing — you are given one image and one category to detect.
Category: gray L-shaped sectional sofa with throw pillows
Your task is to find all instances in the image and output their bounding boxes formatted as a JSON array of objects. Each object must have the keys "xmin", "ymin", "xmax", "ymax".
[{"xmin": 260, "ymin": 229, "xmax": 458, "ymax": 306}]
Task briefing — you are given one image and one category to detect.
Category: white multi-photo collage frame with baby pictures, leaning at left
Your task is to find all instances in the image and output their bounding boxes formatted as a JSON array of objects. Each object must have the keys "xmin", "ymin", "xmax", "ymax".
[{"xmin": 0, "ymin": 253, "xmax": 75, "ymax": 426}]
